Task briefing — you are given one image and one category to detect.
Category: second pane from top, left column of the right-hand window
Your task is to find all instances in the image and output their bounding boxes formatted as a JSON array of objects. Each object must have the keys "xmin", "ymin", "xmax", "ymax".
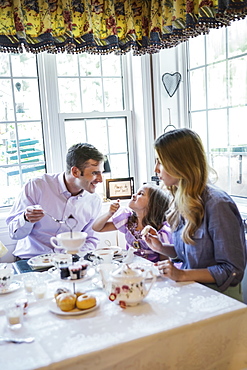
[{"xmin": 190, "ymin": 68, "xmax": 206, "ymax": 110}]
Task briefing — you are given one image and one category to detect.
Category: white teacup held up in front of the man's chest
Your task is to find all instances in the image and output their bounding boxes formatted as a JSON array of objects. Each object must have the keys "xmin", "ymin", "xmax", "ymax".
[{"xmin": 50, "ymin": 231, "xmax": 87, "ymax": 254}]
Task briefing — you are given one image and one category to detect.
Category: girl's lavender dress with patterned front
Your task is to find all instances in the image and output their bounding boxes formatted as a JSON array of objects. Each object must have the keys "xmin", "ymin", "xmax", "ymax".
[{"xmin": 112, "ymin": 208, "xmax": 172, "ymax": 262}]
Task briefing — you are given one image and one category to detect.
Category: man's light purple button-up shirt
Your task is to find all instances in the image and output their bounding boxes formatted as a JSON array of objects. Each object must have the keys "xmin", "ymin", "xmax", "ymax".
[{"xmin": 6, "ymin": 173, "xmax": 102, "ymax": 258}]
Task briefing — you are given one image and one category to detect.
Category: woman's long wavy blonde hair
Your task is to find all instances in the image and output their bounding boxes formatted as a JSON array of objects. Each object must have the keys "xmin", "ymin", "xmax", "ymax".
[{"xmin": 154, "ymin": 128, "xmax": 208, "ymax": 244}]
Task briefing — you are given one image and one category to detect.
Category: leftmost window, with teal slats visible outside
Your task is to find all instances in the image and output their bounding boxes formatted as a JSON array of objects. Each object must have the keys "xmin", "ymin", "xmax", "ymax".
[{"xmin": 0, "ymin": 53, "xmax": 45, "ymax": 207}]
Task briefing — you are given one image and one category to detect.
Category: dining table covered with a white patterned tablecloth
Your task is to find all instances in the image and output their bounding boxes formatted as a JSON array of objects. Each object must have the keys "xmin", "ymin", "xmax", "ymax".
[{"xmin": 0, "ymin": 257, "xmax": 247, "ymax": 370}]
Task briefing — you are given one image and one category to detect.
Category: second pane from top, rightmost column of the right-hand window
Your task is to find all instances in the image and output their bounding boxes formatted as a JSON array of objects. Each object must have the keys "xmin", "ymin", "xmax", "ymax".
[{"xmin": 229, "ymin": 56, "xmax": 247, "ymax": 105}]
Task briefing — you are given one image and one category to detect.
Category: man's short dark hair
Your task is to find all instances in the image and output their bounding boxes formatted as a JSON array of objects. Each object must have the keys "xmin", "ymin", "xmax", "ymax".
[{"xmin": 66, "ymin": 143, "xmax": 104, "ymax": 173}]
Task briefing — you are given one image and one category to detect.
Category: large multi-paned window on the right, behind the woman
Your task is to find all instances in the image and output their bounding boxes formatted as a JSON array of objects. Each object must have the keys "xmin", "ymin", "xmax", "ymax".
[{"xmin": 188, "ymin": 18, "xmax": 247, "ymax": 197}]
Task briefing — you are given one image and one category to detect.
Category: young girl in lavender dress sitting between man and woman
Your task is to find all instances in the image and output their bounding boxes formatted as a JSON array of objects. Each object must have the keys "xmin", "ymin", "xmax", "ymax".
[{"xmin": 93, "ymin": 185, "xmax": 172, "ymax": 262}]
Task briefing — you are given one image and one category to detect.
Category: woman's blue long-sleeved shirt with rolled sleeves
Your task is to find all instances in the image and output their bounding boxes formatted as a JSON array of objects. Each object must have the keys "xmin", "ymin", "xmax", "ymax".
[{"xmin": 173, "ymin": 185, "xmax": 246, "ymax": 291}]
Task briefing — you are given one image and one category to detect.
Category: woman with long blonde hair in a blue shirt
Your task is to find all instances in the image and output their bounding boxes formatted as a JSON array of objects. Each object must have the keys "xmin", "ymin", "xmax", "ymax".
[{"xmin": 145, "ymin": 128, "xmax": 246, "ymax": 300}]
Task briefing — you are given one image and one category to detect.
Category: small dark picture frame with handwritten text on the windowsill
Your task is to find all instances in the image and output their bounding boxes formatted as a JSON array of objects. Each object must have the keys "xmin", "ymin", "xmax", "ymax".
[{"xmin": 106, "ymin": 177, "xmax": 134, "ymax": 200}]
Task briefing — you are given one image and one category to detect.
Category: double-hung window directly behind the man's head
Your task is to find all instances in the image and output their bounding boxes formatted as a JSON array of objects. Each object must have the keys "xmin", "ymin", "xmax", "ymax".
[{"xmin": 56, "ymin": 53, "xmax": 130, "ymax": 181}]
